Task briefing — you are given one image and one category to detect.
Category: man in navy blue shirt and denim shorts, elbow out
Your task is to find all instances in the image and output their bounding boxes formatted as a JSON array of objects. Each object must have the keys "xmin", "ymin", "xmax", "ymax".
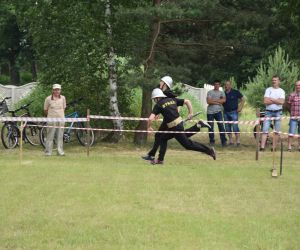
[{"xmin": 223, "ymin": 81, "xmax": 245, "ymax": 146}]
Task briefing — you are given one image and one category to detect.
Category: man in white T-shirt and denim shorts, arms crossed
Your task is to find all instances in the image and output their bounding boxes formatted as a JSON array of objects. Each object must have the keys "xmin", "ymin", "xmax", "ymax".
[{"xmin": 260, "ymin": 76, "xmax": 285, "ymax": 151}]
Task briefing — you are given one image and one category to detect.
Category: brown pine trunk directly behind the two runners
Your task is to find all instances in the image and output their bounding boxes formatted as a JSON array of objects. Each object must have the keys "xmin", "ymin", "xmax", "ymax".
[{"xmin": 134, "ymin": 0, "xmax": 161, "ymax": 145}]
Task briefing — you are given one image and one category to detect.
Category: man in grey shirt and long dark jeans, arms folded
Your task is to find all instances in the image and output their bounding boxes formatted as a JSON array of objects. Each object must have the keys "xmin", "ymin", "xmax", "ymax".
[{"xmin": 206, "ymin": 80, "xmax": 226, "ymax": 146}]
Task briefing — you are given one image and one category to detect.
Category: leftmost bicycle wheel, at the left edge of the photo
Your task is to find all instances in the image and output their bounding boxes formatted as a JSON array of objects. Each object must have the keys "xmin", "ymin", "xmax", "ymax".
[{"xmin": 1, "ymin": 123, "xmax": 19, "ymax": 149}]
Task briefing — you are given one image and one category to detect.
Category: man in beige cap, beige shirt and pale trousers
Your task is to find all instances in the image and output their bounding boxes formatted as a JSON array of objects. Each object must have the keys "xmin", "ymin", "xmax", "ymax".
[{"xmin": 44, "ymin": 84, "xmax": 66, "ymax": 156}]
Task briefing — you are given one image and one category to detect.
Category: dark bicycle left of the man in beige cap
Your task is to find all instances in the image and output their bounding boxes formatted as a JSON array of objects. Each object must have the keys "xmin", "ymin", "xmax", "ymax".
[{"xmin": 1, "ymin": 97, "xmax": 41, "ymax": 149}]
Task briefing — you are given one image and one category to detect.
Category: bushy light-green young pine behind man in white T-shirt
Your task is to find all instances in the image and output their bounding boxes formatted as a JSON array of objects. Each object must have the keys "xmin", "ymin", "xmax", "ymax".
[{"xmin": 245, "ymin": 47, "xmax": 300, "ymax": 109}]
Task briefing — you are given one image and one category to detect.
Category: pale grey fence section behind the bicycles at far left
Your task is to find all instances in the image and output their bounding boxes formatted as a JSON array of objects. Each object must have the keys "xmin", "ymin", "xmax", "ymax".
[{"xmin": 0, "ymin": 82, "xmax": 37, "ymax": 107}]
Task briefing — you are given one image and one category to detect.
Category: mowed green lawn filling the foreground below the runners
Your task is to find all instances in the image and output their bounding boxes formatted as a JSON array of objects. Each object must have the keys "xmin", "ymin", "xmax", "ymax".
[{"xmin": 0, "ymin": 139, "xmax": 300, "ymax": 249}]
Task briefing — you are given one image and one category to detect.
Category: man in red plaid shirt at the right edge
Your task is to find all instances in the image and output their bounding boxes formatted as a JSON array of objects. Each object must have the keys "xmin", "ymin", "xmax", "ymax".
[{"xmin": 287, "ymin": 81, "xmax": 300, "ymax": 152}]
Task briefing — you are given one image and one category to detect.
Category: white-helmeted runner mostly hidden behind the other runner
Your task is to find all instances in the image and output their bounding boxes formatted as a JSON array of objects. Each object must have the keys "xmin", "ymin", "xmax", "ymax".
[{"xmin": 142, "ymin": 76, "xmax": 210, "ymax": 161}]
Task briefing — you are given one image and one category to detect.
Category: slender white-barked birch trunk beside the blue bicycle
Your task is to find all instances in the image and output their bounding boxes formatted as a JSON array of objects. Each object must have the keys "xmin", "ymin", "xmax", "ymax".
[{"xmin": 105, "ymin": 0, "xmax": 123, "ymax": 142}]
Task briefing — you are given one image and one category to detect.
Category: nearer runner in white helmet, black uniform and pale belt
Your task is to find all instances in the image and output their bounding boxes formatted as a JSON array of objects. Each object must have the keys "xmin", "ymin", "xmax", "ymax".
[{"xmin": 148, "ymin": 88, "xmax": 216, "ymax": 164}]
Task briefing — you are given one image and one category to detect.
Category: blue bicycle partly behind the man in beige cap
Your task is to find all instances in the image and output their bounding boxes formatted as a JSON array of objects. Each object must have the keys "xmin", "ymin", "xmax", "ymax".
[{"xmin": 40, "ymin": 98, "xmax": 95, "ymax": 148}]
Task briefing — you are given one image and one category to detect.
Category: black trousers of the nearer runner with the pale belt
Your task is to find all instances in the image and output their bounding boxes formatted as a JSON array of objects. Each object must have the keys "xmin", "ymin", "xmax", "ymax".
[{"xmin": 158, "ymin": 124, "xmax": 211, "ymax": 161}]
